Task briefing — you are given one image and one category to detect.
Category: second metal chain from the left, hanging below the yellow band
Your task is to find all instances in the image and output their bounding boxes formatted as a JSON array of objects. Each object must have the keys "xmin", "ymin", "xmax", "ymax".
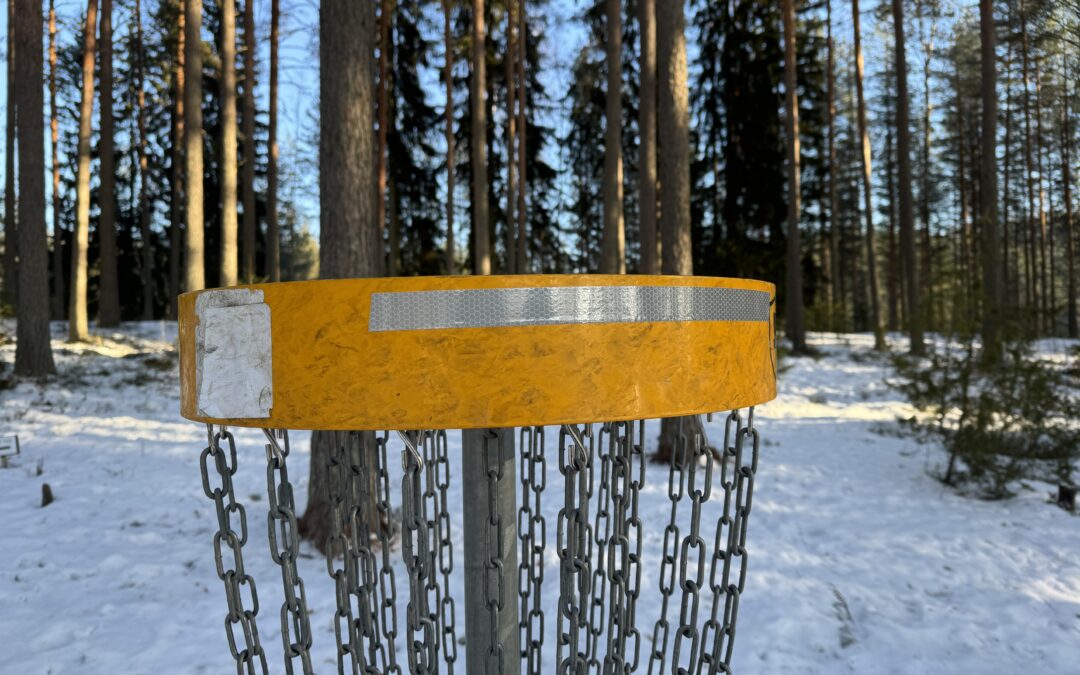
[{"xmin": 262, "ymin": 429, "xmax": 313, "ymax": 675}]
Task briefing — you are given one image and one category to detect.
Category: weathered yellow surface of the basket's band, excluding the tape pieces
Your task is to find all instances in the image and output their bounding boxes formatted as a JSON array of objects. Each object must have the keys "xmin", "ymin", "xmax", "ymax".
[{"xmin": 179, "ymin": 274, "xmax": 777, "ymax": 430}]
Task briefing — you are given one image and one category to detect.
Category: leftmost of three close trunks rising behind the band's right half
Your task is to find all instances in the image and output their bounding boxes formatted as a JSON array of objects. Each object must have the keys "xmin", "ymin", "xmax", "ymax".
[{"xmin": 600, "ymin": 0, "xmax": 626, "ymax": 274}]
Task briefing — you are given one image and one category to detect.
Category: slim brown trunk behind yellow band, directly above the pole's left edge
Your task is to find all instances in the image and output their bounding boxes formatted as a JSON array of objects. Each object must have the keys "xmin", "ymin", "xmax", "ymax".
[{"xmin": 469, "ymin": 0, "xmax": 491, "ymax": 274}]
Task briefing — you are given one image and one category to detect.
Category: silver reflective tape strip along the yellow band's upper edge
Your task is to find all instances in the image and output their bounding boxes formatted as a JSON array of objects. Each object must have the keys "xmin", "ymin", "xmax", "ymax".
[{"xmin": 368, "ymin": 286, "xmax": 769, "ymax": 332}]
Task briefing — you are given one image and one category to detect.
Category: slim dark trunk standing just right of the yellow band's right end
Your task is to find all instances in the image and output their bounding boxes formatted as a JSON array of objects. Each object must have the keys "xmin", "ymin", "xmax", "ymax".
[{"xmin": 781, "ymin": 0, "xmax": 807, "ymax": 353}]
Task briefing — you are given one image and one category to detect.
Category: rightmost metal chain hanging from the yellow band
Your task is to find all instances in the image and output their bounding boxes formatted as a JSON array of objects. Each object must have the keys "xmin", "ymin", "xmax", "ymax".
[{"xmin": 702, "ymin": 408, "xmax": 760, "ymax": 675}]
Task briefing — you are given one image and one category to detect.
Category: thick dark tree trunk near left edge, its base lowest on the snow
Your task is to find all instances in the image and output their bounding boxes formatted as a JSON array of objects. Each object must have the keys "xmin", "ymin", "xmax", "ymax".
[{"xmin": 9, "ymin": 0, "xmax": 56, "ymax": 377}]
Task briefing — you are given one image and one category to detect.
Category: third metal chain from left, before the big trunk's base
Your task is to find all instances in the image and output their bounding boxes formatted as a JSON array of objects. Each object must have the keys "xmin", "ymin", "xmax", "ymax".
[{"xmin": 326, "ymin": 431, "xmax": 367, "ymax": 675}]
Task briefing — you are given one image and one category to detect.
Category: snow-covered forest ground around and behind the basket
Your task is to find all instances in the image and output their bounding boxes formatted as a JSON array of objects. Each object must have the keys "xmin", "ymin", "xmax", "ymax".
[{"xmin": 0, "ymin": 323, "xmax": 1080, "ymax": 675}]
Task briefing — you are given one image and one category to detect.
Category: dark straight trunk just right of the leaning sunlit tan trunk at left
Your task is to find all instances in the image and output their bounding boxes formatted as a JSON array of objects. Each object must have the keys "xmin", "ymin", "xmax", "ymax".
[{"xmin": 97, "ymin": 0, "xmax": 120, "ymax": 327}]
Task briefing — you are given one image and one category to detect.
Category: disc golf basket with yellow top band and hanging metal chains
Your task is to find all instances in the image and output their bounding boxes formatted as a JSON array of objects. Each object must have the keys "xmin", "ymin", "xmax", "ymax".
[{"xmin": 179, "ymin": 275, "xmax": 775, "ymax": 675}]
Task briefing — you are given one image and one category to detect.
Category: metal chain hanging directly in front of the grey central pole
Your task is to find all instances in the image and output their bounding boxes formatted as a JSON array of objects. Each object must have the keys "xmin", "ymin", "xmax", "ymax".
[{"xmin": 483, "ymin": 430, "xmax": 505, "ymax": 675}]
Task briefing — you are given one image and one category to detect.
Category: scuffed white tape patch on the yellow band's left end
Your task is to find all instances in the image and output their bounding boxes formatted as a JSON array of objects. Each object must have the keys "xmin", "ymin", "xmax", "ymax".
[{"xmin": 195, "ymin": 288, "xmax": 273, "ymax": 419}]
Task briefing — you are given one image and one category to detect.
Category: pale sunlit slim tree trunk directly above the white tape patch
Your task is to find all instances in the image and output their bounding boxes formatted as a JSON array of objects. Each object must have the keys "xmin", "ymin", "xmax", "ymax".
[{"xmin": 217, "ymin": 0, "xmax": 238, "ymax": 286}]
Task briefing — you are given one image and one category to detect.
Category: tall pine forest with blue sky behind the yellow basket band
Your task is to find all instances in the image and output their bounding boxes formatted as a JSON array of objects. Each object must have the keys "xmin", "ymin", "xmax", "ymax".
[{"xmin": 0, "ymin": 0, "xmax": 1080, "ymax": 375}]
